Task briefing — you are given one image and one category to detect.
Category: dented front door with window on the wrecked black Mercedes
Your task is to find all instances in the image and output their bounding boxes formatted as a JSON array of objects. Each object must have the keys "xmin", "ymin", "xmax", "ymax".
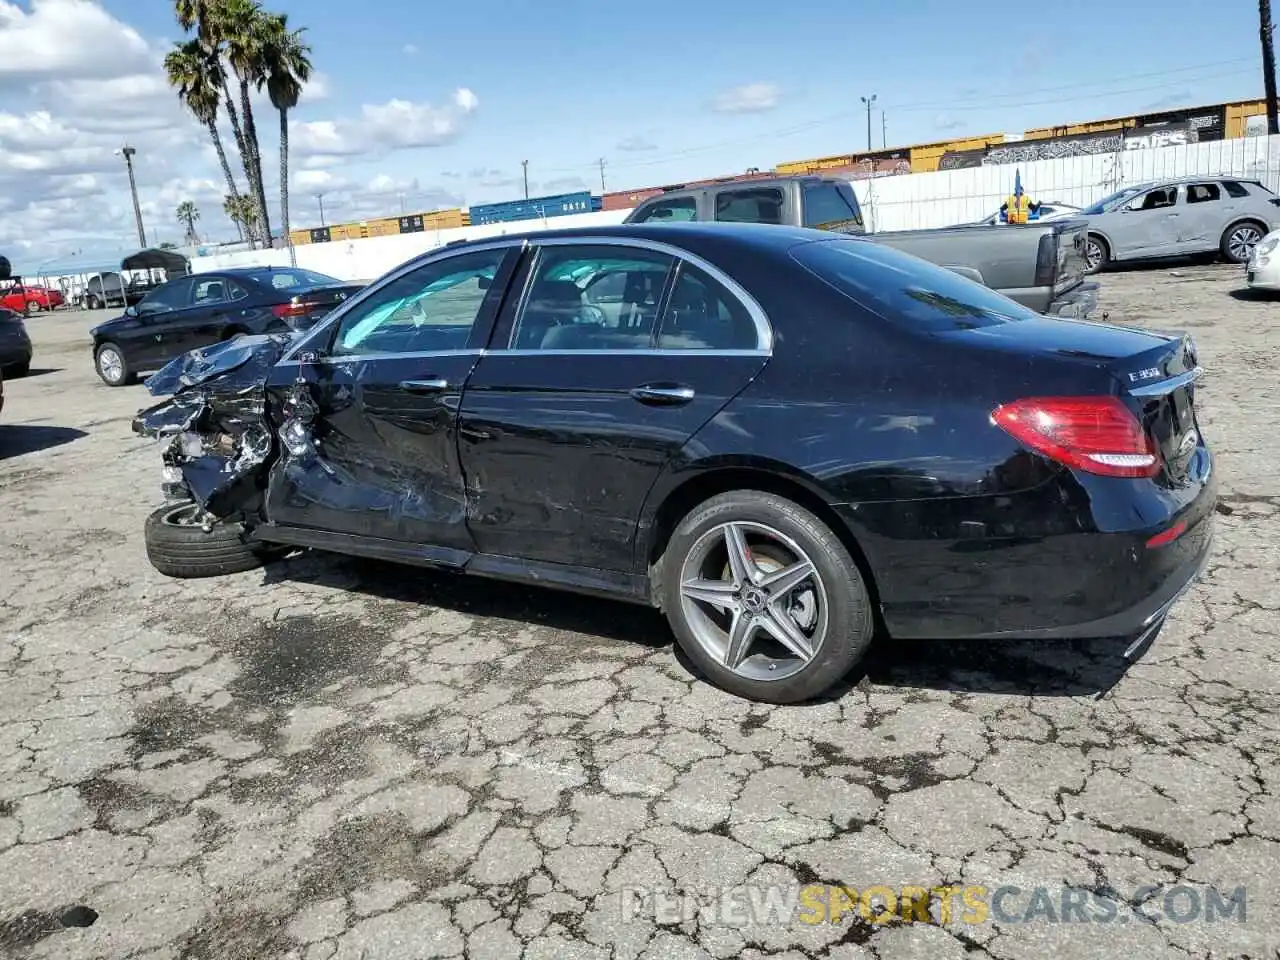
[{"xmin": 268, "ymin": 244, "xmax": 516, "ymax": 550}]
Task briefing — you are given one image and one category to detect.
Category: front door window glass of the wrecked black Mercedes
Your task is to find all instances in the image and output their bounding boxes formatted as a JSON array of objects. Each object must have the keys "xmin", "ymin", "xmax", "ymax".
[{"xmin": 332, "ymin": 248, "xmax": 507, "ymax": 356}]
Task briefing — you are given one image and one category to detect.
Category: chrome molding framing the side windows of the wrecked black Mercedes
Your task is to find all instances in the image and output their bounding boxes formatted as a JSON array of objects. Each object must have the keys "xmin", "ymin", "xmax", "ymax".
[{"xmin": 276, "ymin": 234, "xmax": 773, "ymax": 366}]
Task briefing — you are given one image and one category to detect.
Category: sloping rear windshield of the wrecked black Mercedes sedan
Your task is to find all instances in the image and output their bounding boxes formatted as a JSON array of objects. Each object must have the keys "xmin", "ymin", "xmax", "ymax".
[{"xmin": 791, "ymin": 238, "xmax": 1037, "ymax": 332}]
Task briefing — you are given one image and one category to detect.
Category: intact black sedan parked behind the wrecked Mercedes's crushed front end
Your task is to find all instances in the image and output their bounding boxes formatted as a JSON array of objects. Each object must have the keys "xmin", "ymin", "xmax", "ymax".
[{"xmin": 91, "ymin": 266, "xmax": 362, "ymax": 387}]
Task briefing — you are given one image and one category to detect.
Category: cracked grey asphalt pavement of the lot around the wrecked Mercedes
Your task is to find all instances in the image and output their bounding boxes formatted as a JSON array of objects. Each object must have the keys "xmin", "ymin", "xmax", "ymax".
[{"xmin": 0, "ymin": 259, "xmax": 1280, "ymax": 960}]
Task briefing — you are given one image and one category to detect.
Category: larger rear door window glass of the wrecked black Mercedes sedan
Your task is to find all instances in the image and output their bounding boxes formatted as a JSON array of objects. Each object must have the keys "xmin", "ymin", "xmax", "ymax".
[{"xmin": 511, "ymin": 244, "xmax": 675, "ymax": 351}]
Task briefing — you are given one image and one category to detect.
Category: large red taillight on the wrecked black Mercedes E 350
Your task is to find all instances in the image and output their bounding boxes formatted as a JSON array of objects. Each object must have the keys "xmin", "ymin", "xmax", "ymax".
[{"xmin": 991, "ymin": 397, "xmax": 1160, "ymax": 476}]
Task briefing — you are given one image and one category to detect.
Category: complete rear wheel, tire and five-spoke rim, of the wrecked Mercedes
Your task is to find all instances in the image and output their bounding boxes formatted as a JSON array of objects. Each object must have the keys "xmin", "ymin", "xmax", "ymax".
[{"xmin": 662, "ymin": 490, "xmax": 874, "ymax": 703}]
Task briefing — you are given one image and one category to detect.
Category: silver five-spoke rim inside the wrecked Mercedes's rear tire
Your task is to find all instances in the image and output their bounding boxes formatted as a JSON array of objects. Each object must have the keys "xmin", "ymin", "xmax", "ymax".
[{"xmin": 680, "ymin": 521, "xmax": 829, "ymax": 680}]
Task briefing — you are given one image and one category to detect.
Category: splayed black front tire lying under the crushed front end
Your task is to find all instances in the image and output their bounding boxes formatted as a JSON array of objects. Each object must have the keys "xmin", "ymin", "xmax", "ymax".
[{"xmin": 145, "ymin": 503, "xmax": 271, "ymax": 580}]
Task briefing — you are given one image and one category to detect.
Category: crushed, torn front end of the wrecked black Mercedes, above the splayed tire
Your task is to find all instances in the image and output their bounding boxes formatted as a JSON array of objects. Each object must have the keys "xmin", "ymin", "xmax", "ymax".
[{"xmin": 133, "ymin": 335, "xmax": 296, "ymax": 524}]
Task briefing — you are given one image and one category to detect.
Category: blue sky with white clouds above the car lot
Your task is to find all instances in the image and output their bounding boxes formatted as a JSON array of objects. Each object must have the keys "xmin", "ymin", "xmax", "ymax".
[{"xmin": 0, "ymin": 0, "xmax": 1262, "ymax": 263}]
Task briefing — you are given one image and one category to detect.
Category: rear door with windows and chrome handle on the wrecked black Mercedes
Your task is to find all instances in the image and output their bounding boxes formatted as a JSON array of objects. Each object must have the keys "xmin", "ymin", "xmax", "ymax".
[{"xmin": 458, "ymin": 239, "xmax": 769, "ymax": 572}]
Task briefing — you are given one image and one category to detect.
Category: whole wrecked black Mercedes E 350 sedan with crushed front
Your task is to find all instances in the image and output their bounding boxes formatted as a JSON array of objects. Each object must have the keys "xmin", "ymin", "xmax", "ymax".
[{"xmin": 134, "ymin": 224, "xmax": 1215, "ymax": 703}]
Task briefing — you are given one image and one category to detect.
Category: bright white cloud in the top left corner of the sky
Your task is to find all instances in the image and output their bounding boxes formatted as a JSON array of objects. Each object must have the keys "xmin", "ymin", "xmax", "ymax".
[{"xmin": 0, "ymin": 0, "xmax": 150, "ymax": 83}]
